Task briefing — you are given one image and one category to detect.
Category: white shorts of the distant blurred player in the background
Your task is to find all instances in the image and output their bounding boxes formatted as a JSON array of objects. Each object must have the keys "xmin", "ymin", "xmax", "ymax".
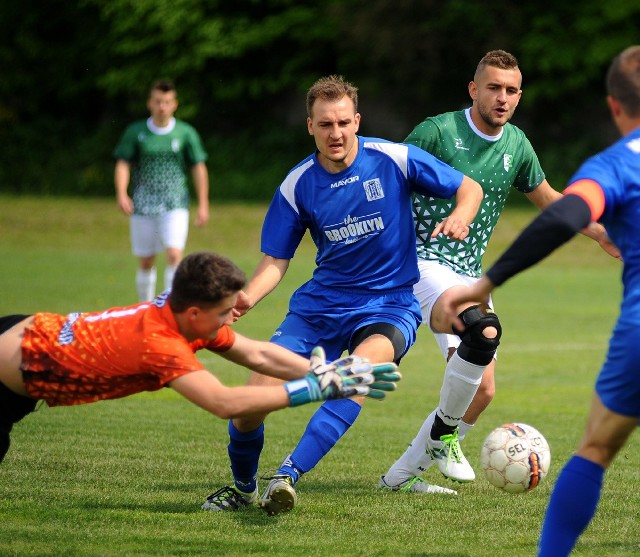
[{"xmin": 130, "ymin": 209, "xmax": 189, "ymax": 257}]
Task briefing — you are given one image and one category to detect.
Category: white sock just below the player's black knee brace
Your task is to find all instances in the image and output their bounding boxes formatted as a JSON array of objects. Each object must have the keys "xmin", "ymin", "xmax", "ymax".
[{"xmin": 438, "ymin": 351, "xmax": 487, "ymax": 426}]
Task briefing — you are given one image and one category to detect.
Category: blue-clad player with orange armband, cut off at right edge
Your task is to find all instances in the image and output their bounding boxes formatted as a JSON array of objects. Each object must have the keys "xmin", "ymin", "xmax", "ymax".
[{"xmin": 444, "ymin": 45, "xmax": 640, "ymax": 557}]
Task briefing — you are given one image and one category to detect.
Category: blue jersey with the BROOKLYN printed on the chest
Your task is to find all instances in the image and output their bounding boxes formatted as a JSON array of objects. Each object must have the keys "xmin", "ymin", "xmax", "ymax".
[{"xmin": 262, "ymin": 137, "xmax": 464, "ymax": 291}]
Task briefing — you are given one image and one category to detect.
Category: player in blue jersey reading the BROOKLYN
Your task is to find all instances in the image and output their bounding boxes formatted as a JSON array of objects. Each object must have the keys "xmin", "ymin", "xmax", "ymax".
[{"xmin": 203, "ymin": 76, "xmax": 482, "ymax": 514}]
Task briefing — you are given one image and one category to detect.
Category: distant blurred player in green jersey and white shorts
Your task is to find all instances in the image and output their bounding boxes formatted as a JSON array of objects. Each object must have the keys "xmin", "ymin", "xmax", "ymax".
[{"xmin": 113, "ymin": 81, "xmax": 209, "ymax": 301}]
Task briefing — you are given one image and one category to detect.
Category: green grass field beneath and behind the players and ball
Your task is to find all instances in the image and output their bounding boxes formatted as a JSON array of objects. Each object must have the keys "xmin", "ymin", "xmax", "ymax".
[{"xmin": 0, "ymin": 197, "xmax": 640, "ymax": 557}]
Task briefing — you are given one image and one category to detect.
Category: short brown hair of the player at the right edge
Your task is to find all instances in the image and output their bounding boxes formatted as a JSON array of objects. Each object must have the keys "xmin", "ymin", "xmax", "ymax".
[{"xmin": 607, "ymin": 45, "xmax": 640, "ymax": 118}]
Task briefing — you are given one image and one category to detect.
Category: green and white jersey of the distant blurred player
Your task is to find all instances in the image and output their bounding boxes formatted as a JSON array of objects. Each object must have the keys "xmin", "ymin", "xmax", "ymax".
[{"xmin": 113, "ymin": 118, "xmax": 207, "ymax": 216}]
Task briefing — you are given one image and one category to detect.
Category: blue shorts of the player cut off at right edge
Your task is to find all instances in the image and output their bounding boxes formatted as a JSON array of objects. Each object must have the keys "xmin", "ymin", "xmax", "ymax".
[{"xmin": 596, "ymin": 321, "xmax": 640, "ymax": 417}]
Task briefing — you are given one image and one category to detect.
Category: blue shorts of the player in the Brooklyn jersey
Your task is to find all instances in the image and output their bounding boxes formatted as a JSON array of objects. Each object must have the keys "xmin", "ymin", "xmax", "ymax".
[{"xmin": 271, "ymin": 279, "xmax": 422, "ymax": 360}]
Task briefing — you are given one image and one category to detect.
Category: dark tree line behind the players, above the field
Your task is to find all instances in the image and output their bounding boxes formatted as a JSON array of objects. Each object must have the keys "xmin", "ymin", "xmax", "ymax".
[{"xmin": 0, "ymin": 0, "xmax": 640, "ymax": 201}]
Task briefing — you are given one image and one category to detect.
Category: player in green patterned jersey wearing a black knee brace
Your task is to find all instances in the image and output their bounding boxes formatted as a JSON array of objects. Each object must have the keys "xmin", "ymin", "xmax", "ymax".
[{"xmin": 379, "ymin": 50, "xmax": 619, "ymax": 492}]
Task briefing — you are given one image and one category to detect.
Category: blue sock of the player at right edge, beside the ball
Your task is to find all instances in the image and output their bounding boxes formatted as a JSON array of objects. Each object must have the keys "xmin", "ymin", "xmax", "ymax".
[{"xmin": 538, "ymin": 455, "xmax": 605, "ymax": 557}]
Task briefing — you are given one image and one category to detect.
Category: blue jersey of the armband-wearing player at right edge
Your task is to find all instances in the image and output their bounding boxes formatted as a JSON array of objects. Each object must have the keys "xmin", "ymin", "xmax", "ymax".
[{"xmin": 570, "ymin": 130, "xmax": 640, "ymax": 326}]
